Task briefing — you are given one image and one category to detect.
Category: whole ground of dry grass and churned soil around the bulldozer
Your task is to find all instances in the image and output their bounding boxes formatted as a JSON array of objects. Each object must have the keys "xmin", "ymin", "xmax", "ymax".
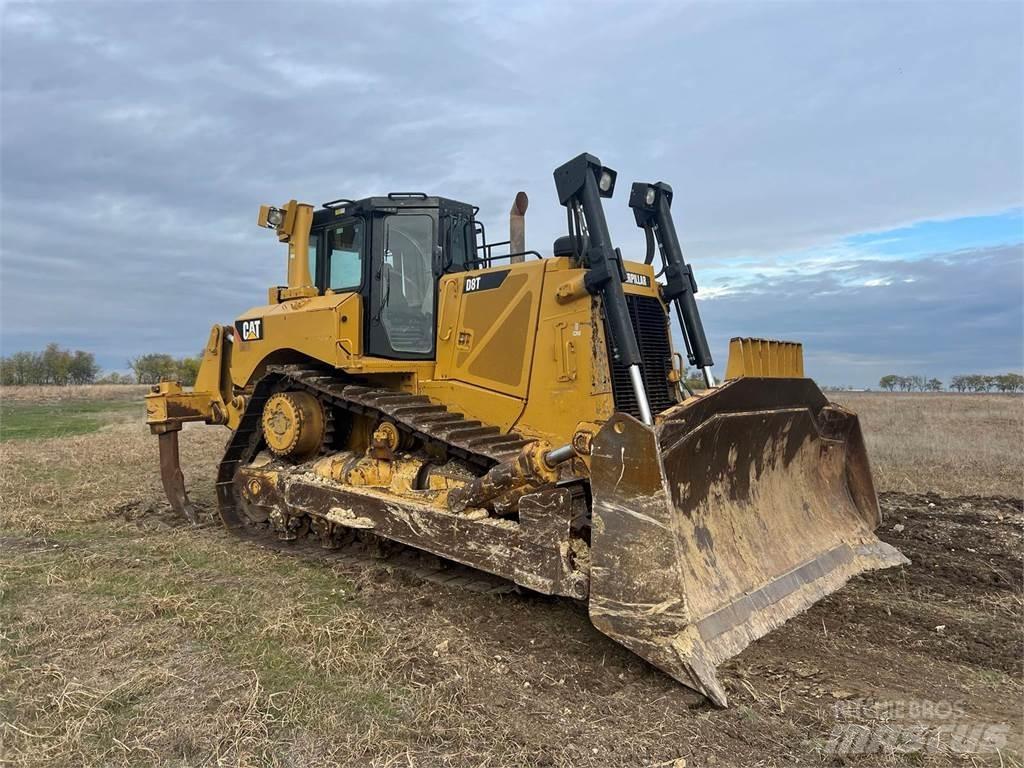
[{"xmin": 0, "ymin": 388, "xmax": 1024, "ymax": 768}]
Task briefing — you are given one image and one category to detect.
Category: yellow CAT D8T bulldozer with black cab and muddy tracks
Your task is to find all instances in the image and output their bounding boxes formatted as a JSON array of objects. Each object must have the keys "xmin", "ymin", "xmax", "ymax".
[{"xmin": 146, "ymin": 154, "xmax": 907, "ymax": 707}]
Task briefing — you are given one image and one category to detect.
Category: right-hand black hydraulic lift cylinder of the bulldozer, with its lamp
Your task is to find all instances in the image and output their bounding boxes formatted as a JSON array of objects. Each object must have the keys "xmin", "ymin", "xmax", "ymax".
[{"xmin": 630, "ymin": 181, "xmax": 715, "ymax": 387}]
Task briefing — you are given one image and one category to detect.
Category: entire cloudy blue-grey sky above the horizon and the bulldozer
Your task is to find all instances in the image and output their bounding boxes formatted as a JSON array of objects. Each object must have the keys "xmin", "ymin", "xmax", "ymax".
[{"xmin": 0, "ymin": 1, "xmax": 1024, "ymax": 385}]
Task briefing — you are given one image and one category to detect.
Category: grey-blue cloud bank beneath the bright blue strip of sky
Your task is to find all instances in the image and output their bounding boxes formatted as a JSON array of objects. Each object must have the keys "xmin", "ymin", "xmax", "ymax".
[{"xmin": 697, "ymin": 245, "xmax": 1024, "ymax": 386}]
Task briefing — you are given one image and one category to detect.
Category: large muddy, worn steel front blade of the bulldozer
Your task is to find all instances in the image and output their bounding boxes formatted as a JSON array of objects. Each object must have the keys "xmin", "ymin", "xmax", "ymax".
[{"xmin": 590, "ymin": 378, "xmax": 908, "ymax": 707}]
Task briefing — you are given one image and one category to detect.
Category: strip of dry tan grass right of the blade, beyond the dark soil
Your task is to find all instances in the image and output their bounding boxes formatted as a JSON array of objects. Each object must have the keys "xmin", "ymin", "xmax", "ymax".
[{"xmin": 829, "ymin": 392, "xmax": 1024, "ymax": 498}]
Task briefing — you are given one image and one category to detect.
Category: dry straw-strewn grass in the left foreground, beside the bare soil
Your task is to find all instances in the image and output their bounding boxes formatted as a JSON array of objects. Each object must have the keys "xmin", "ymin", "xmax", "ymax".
[{"xmin": 0, "ymin": 425, "xmax": 497, "ymax": 765}]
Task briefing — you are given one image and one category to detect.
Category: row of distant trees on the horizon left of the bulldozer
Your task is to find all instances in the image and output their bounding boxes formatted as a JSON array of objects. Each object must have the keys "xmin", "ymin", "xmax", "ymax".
[{"xmin": 0, "ymin": 342, "xmax": 201, "ymax": 386}]
